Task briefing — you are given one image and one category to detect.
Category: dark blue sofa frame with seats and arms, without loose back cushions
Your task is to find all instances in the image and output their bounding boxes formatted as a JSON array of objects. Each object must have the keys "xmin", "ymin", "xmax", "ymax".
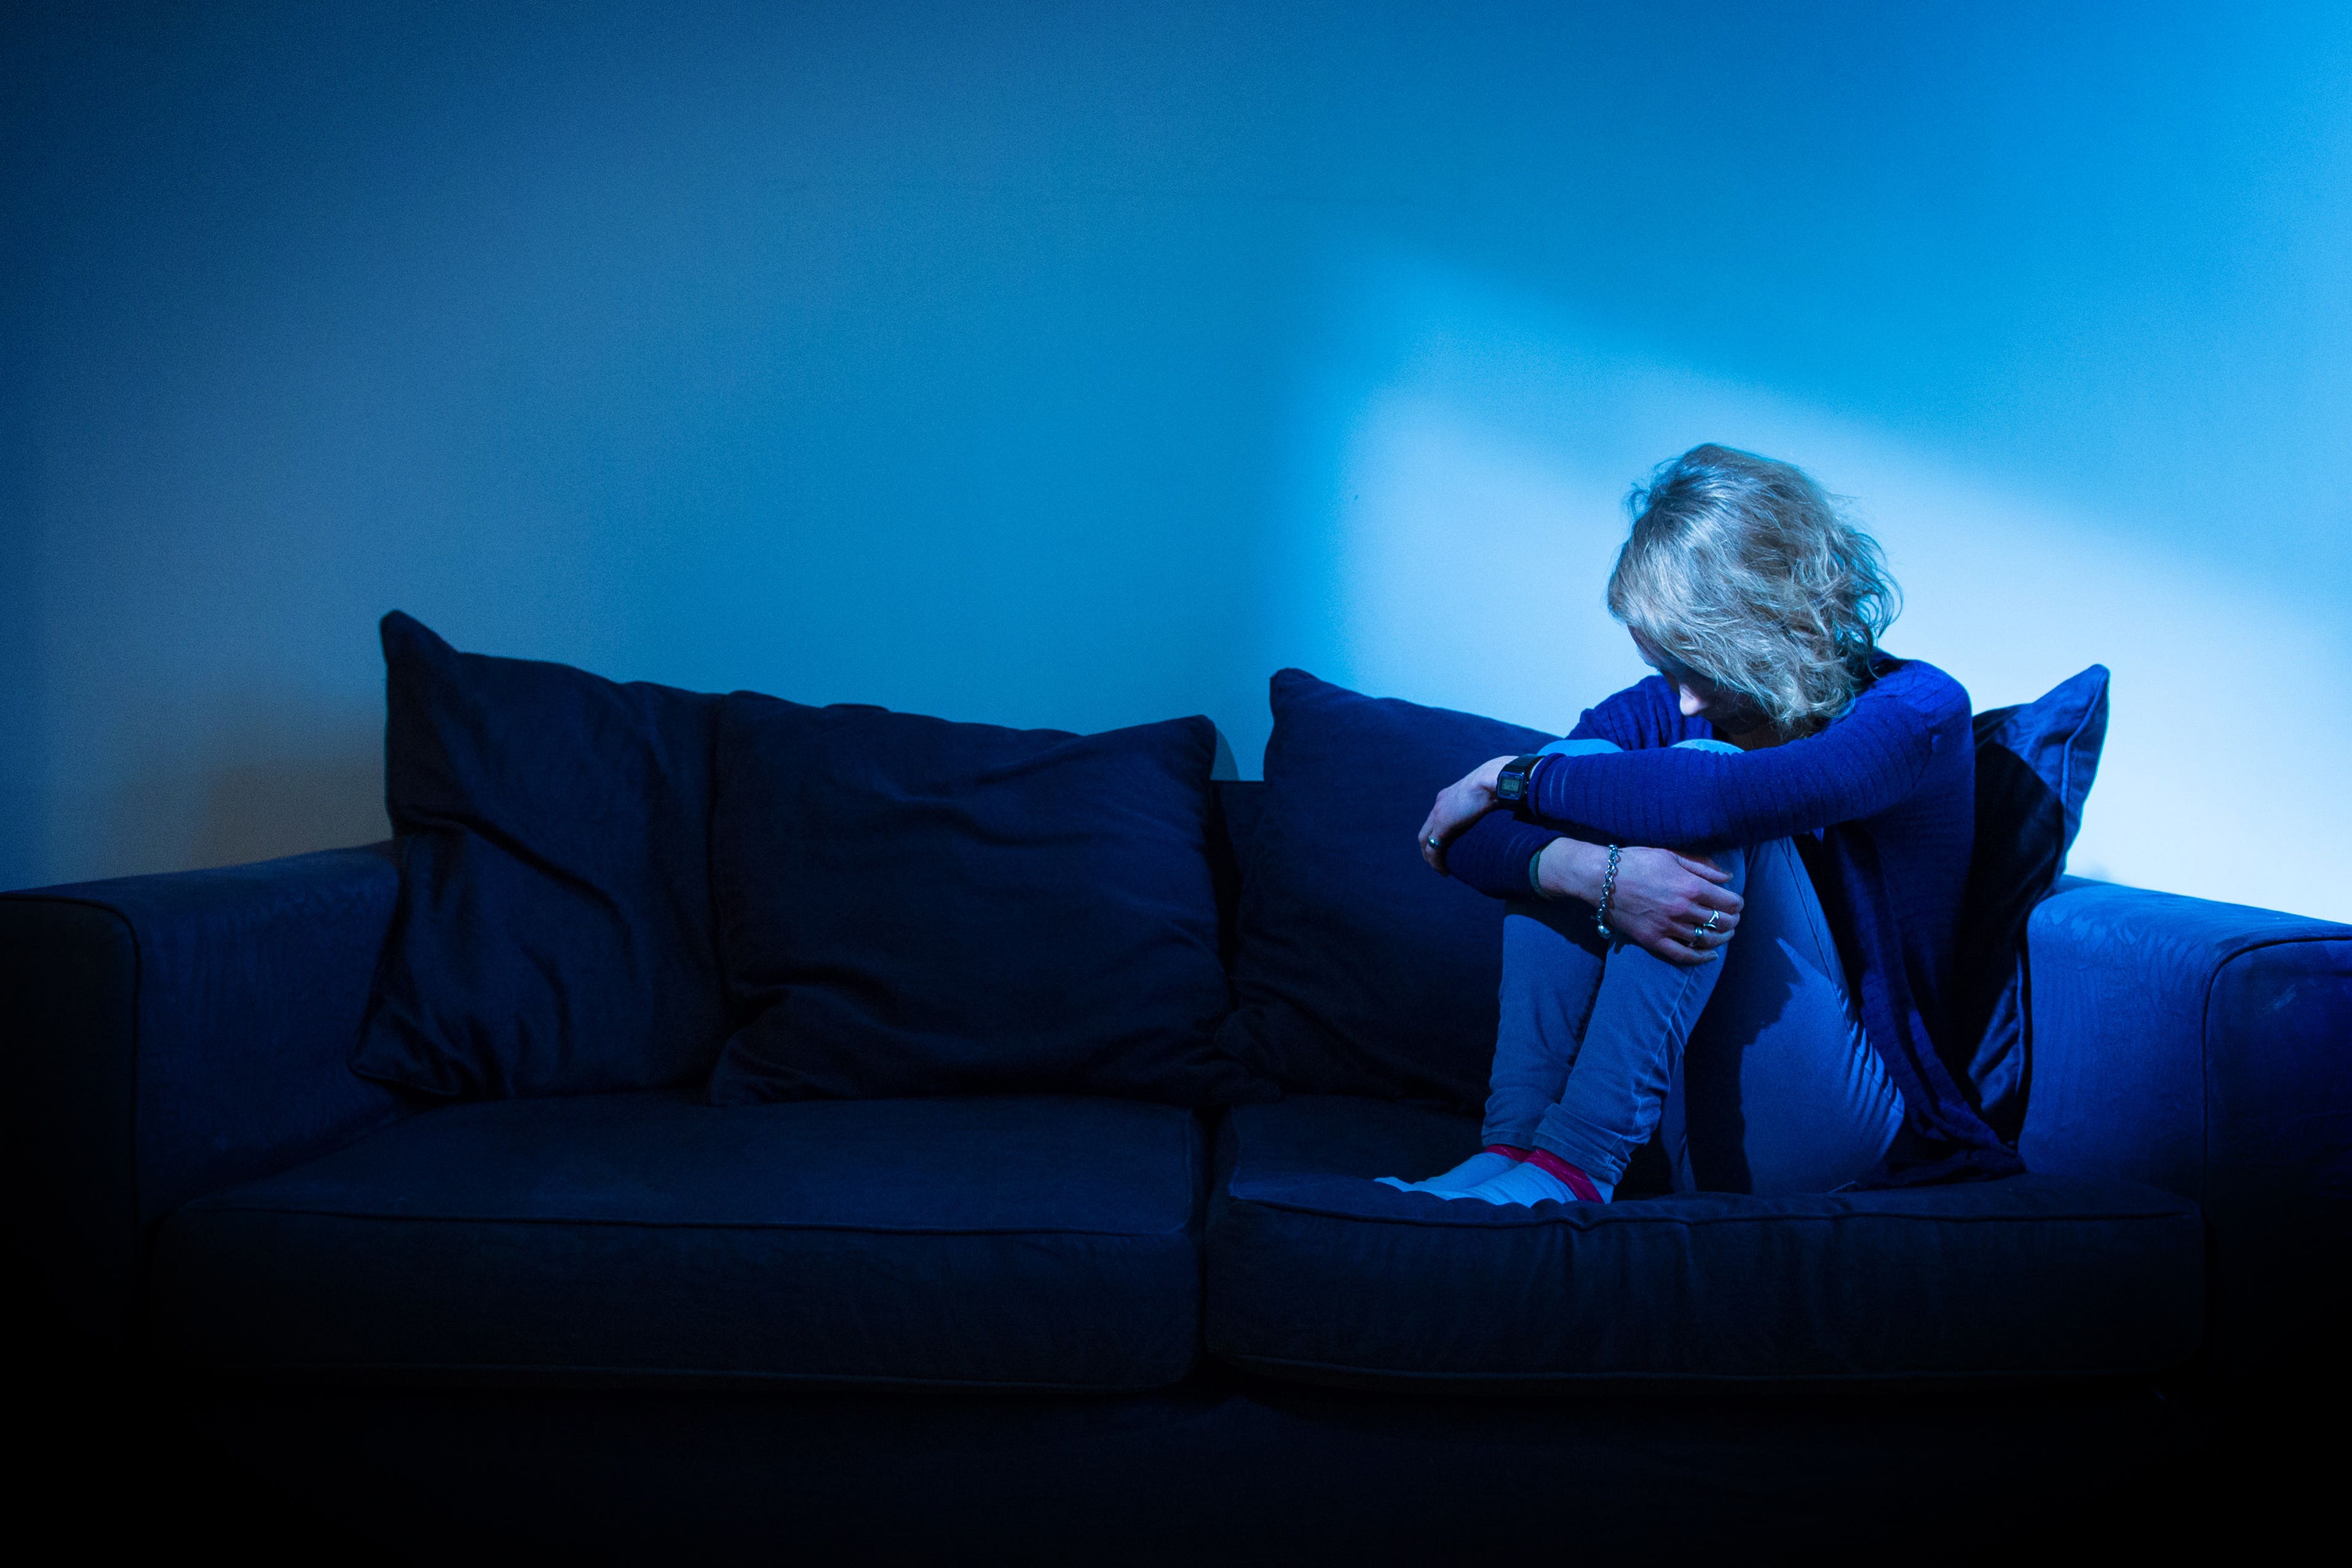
[{"xmin": 0, "ymin": 783, "xmax": 2352, "ymax": 1561}]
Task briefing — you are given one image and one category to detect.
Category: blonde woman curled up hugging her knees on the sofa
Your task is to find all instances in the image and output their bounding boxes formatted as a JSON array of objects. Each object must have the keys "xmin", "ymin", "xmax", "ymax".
[{"xmin": 1383, "ymin": 446, "xmax": 2018, "ymax": 1203}]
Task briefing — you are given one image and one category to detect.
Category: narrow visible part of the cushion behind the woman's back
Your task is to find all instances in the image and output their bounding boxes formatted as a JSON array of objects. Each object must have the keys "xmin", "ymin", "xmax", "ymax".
[{"xmin": 1950, "ymin": 665, "xmax": 2107, "ymax": 1147}]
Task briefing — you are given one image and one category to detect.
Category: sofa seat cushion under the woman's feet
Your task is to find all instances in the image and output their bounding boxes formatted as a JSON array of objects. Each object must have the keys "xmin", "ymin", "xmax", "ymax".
[{"xmin": 1206, "ymin": 1096, "xmax": 2204, "ymax": 1392}]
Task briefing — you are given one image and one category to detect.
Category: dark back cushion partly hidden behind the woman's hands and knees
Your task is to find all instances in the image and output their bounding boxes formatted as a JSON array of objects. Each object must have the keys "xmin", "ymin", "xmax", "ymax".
[{"xmin": 1225, "ymin": 670, "xmax": 1553, "ymax": 1109}]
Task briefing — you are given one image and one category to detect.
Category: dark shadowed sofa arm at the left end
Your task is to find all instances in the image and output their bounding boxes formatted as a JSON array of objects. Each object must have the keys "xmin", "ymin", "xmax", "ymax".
[{"xmin": 0, "ymin": 846, "xmax": 405, "ymax": 1342}]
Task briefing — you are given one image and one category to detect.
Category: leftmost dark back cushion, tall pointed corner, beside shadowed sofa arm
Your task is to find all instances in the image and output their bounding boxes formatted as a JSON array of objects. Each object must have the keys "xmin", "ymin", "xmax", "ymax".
[{"xmin": 353, "ymin": 611, "xmax": 727, "ymax": 1098}]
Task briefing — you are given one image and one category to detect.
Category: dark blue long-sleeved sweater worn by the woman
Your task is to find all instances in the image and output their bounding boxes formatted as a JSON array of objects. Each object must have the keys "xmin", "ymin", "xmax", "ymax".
[{"xmin": 1446, "ymin": 658, "xmax": 2023, "ymax": 1185}]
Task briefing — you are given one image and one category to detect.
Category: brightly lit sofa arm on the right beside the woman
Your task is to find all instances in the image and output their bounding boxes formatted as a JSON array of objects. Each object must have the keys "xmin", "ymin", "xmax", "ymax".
[{"xmin": 2018, "ymin": 879, "xmax": 2352, "ymax": 1385}]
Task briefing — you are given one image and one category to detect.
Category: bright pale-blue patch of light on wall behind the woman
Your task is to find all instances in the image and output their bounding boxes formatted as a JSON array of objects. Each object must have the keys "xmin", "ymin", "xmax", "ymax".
[{"xmin": 1284, "ymin": 259, "xmax": 2352, "ymax": 914}]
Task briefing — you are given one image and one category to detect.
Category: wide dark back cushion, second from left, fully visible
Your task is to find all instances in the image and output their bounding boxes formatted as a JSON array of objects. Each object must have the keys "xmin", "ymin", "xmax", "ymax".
[{"xmin": 710, "ymin": 691, "xmax": 1270, "ymax": 1105}]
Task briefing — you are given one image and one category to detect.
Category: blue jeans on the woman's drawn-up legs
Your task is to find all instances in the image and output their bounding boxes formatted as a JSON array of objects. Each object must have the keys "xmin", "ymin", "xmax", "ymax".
[{"xmin": 1484, "ymin": 740, "xmax": 1903, "ymax": 1194}]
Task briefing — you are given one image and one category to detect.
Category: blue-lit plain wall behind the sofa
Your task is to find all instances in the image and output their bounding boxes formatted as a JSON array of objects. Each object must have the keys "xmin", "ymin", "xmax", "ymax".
[{"xmin": 0, "ymin": 0, "xmax": 2352, "ymax": 917}]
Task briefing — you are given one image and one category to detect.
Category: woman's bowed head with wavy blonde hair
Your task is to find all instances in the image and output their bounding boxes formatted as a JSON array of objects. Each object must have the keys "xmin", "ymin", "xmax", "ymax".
[{"xmin": 1609, "ymin": 446, "xmax": 1903, "ymax": 734}]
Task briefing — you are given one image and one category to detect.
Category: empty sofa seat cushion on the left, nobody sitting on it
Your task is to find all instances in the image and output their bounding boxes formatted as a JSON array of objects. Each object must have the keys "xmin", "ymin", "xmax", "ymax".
[{"xmin": 155, "ymin": 1091, "xmax": 1204, "ymax": 1389}]
